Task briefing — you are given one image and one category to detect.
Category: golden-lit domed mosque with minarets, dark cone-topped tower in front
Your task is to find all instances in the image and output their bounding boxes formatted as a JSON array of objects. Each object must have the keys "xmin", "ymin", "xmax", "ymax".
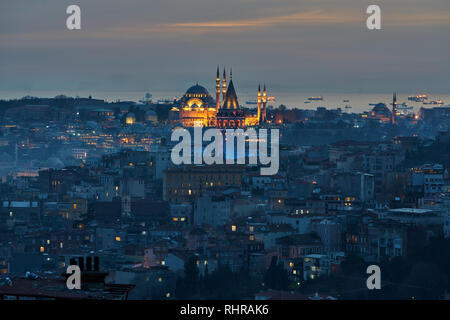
[{"xmin": 171, "ymin": 67, "xmax": 267, "ymax": 128}]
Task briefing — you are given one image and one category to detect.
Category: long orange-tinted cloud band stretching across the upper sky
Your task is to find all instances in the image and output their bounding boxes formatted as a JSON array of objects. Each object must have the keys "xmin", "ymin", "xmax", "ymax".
[{"xmin": 0, "ymin": 8, "xmax": 450, "ymax": 46}]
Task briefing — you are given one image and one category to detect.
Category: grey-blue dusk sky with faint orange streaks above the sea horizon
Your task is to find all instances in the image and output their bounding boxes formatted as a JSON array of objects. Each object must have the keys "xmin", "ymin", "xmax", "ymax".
[{"xmin": 0, "ymin": 0, "xmax": 450, "ymax": 98}]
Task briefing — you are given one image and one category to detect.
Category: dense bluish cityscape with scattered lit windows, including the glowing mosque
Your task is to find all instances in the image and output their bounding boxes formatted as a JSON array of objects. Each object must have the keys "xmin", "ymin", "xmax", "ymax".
[{"xmin": 0, "ymin": 88, "xmax": 450, "ymax": 299}]
